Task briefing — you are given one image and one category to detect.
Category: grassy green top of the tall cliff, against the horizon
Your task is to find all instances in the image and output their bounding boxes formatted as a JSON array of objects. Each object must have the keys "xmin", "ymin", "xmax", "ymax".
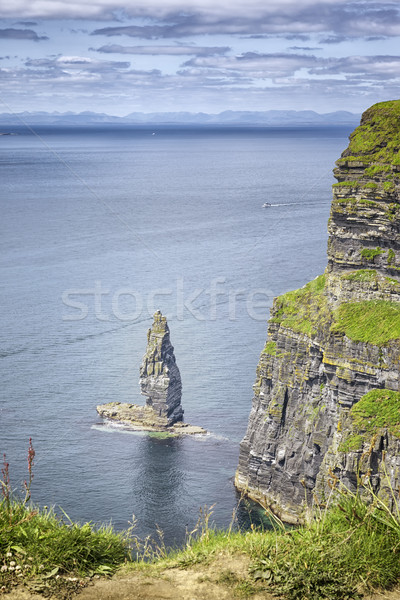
[{"xmin": 338, "ymin": 100, "xmax": 400, "ymax": 165}]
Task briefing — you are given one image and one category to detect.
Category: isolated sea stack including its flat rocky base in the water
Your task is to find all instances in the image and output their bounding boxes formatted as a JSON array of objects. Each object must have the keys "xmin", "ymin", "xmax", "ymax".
[{"xmin": 97, "ymin": 310, "xmax": 206, "ymax": 435}]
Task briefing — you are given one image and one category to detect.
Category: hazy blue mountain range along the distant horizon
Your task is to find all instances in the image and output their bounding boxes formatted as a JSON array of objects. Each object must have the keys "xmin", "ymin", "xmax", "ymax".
[{"xmin": 0, "ymin": 110, "xmax": 360, "ymax": 129}]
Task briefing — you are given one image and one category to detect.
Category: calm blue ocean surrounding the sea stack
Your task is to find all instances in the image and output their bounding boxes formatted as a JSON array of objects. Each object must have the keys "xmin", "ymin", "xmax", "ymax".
[{"xmin": 0, "ymin": 126, "xmax": 350, "ymax": 545}]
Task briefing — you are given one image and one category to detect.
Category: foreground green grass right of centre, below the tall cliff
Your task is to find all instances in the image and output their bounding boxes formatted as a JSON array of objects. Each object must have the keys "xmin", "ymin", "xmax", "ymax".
[{"xmin": 145, "ymin": 490, "xmax": 400, "ymax": 600}]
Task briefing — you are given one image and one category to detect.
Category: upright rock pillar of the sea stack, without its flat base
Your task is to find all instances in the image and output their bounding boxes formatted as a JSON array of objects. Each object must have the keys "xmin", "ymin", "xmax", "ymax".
[{"xmin": 140, "ymin": 310, "xmax": 183, "ymax": 427}]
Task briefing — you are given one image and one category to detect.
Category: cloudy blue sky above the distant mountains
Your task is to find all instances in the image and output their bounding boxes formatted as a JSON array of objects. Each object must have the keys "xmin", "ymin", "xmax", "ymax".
[{"xmin": 0, "ymin": 0, "xmax": 400, "ymax": 116}]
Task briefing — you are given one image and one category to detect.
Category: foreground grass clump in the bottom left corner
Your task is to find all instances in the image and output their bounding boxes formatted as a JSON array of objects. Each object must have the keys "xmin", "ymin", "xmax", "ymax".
[{"xmin": 0, "ymin": 499, "xmax": 129, "ymax": 589}]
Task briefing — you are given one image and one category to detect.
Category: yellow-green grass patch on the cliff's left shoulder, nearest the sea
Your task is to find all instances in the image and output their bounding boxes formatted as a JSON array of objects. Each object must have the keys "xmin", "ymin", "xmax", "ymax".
[{"xmin": 270, "ymin": 275, "xmax": 328, "ymax": 336}]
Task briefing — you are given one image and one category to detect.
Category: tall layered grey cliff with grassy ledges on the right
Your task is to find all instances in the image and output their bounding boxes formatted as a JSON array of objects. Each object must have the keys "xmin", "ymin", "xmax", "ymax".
[{"xmin": 236, "ymin": 101, "xmax": 400, "ymax": 522}]
